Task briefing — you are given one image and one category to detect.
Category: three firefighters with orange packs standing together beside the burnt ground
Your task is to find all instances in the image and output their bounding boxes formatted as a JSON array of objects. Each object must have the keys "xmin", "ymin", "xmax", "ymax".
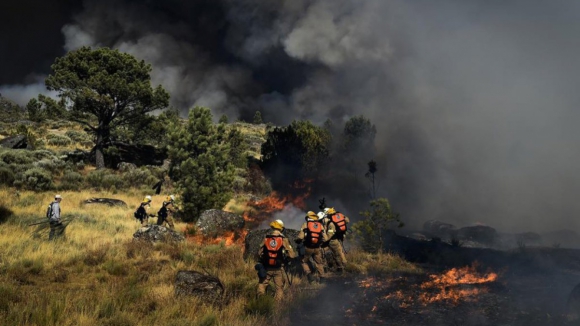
[{"xmin": 256, "ymin": 207, "xmax": 350, "ymax": 301}]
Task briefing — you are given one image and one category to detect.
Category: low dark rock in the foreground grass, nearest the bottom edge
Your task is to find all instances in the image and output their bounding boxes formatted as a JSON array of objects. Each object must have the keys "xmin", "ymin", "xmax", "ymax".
[{"xmin": 175, "ymin": 271, "xmax": 224, "ymax": 302}]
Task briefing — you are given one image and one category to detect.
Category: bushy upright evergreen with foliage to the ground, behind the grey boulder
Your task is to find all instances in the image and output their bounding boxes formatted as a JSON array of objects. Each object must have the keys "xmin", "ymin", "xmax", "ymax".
[{"xmin": 168, "ymin": 107, "xmax": 235, "ymax": 222}]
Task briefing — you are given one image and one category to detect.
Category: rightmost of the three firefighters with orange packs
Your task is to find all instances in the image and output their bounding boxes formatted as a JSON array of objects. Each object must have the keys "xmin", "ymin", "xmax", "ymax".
[{"xmin": 324, "ymin": 207, "xmax": 350, "ymax": 273}]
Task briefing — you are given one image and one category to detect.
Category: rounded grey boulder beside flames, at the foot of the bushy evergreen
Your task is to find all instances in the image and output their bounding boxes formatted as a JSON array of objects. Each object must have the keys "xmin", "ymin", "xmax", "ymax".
[{"xmin": 195, "ymin": 209, "xmax": 245, "ymax": 237}]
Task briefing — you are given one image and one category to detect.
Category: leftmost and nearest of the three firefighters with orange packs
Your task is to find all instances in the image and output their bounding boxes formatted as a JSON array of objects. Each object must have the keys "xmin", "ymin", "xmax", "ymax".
[{"xmin": 256, "ymin": 221, "xmax": 296, "ymax": 301}]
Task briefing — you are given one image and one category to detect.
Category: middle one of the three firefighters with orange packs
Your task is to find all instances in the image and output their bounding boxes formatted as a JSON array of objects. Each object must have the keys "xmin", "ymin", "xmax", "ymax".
[{"xmin": 295, "ymin": 211, "xmax": 328, "ymax": 283}]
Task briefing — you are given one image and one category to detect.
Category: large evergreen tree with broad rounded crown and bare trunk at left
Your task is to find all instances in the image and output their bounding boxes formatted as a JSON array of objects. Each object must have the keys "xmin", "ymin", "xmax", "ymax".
[{"xmin": 45, "ymin": 47, "xmax": 169, "ymax": 168}]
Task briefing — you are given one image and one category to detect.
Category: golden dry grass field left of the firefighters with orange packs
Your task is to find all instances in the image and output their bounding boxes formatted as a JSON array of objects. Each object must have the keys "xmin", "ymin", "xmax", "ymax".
[{"xmin": 0, "ymin": 189, "xmax": 274, "ymax": 326}]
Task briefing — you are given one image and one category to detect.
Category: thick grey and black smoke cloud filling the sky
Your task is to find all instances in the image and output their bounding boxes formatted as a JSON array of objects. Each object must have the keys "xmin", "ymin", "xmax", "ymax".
[{"xmin": 1, "ymin": 0, "xmax": 580, "ymax": 231}]
